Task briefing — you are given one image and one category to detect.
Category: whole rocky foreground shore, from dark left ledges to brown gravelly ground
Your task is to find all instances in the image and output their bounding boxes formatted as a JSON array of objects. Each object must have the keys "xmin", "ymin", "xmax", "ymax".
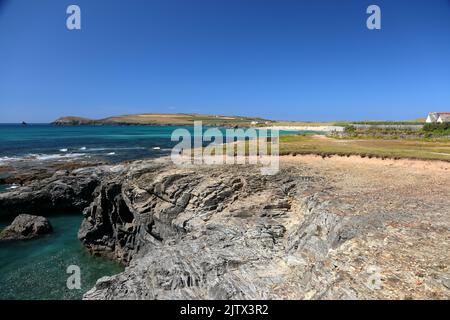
[{"xmin": 0, "ymin": 157, "xmax": 450, "ymax": 299}]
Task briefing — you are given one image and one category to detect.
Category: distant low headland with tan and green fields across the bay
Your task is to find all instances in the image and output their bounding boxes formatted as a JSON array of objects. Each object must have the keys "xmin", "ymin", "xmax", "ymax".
[{"xmin": 53, "ymin": 113, "xmax": 272, "ymax": 126}]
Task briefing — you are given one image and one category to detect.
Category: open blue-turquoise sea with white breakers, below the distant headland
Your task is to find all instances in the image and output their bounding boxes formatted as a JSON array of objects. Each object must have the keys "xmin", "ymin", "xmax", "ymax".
[{"xmin": 0, "ymin": 124, "xmax": 185, "ymax": 165}]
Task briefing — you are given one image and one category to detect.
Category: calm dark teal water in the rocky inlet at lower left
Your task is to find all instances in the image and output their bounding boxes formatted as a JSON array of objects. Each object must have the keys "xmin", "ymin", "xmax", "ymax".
[{"xmin": 0, "ymin": 214, "xmax": 123, "ymax": 299}]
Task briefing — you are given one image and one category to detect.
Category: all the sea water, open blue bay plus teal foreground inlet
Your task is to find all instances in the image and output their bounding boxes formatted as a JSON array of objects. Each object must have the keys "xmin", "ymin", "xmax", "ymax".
[{"xmin": 0, "ymin": 124, "xmax": 310, "ymax": 300}]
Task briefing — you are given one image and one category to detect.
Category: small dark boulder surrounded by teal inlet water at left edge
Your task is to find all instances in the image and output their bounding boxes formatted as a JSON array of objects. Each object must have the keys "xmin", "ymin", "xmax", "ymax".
[{"xmin": 0, "ymin": 214, "xmax": 52, "ymax": 240}]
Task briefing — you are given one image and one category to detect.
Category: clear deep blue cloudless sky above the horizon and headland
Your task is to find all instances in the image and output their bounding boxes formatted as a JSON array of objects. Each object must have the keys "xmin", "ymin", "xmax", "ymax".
[{"xmin": 0, "ymin": 0, "xmax": 450, "ymax": 122}]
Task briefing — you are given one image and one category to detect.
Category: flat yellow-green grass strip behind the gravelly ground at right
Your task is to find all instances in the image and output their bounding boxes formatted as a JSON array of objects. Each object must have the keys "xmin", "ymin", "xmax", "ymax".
[{"xmin": 280, "ymin": 135, "xmax": 450, "ymax": 161}]
